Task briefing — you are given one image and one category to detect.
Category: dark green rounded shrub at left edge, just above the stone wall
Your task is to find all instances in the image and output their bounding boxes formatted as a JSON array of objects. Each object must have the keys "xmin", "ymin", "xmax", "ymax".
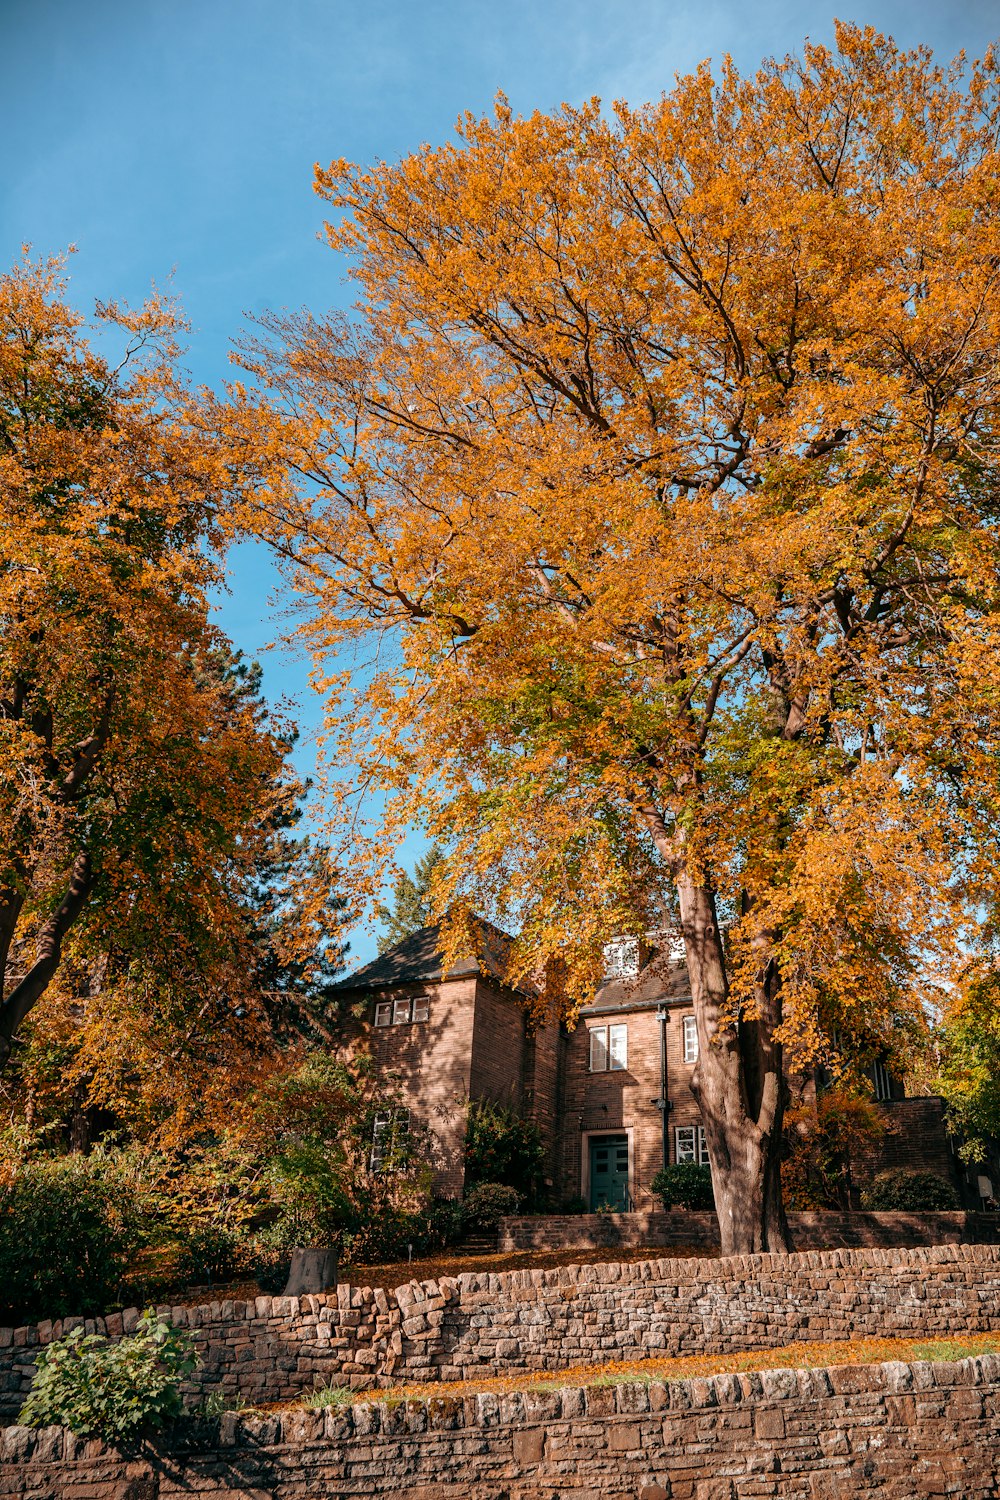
[{"xmin": 0, "ymin": 1155, "xmax": 141, "ymax": 1323}]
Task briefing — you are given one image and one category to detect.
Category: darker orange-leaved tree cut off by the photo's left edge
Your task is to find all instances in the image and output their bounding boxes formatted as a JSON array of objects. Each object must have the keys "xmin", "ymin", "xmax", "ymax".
[{"xmin": 0, "ymin": 261, "xmax": 344, "ymax": 1110}]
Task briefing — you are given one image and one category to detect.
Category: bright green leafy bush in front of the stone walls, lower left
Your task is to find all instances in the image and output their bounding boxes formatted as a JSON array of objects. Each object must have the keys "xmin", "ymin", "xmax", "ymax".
[{"xmin": 19, "ymin": 1310, "xmax": 198, "ymax": 1442}]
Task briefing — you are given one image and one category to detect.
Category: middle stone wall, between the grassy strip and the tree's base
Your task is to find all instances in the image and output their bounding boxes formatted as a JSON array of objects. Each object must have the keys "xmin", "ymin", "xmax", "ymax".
[{"xmin": 0, "ymin": 1245, "xmax": 1000, "ymax": 1419}]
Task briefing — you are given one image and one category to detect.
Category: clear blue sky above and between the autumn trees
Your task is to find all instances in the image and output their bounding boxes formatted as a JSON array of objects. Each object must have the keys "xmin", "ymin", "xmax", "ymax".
[{"xmin": 0, "ymin": 0, "xmax": 1000, "ymax": 956}]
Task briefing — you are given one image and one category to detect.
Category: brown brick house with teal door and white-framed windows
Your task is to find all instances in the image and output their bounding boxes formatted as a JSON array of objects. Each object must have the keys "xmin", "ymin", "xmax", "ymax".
[{"xmin": 337, "ymin": 924, "xmax": 981, "ymax": 1211}]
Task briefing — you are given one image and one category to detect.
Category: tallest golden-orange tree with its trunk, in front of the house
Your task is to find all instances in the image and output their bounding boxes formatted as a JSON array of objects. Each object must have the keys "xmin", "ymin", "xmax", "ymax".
[{"xmin": 230, "ymin": 26, "xmax": 1000, "ymax": 1251}]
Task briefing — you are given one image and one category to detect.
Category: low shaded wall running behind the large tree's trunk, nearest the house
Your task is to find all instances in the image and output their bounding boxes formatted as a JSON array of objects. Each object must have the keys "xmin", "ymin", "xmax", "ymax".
[{"xmin": 499, "ymin": 1211, "xmax": 1000, "ymax": 1253}]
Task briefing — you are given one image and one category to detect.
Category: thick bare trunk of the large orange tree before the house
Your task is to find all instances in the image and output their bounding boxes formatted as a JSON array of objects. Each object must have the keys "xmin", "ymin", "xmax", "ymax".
[{"xmin": 678, "ymin": 878, "xmax": 789, "ymax": 1256}]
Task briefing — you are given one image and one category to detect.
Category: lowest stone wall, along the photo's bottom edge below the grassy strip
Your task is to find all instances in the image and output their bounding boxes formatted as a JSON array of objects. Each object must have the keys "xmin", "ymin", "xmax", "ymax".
[{"xmin": 0, "ymin": 1356, "xmax": 1000, "ymax": 1500}]
